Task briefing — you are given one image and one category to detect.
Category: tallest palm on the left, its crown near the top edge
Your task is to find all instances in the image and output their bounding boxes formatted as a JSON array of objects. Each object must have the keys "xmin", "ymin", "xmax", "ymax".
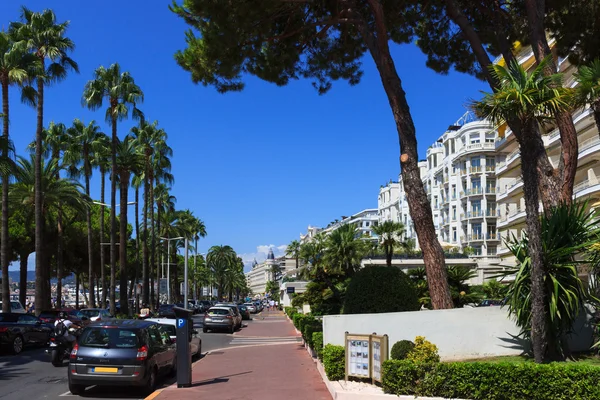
[{"xmin": 9, "ymin": 7, "xmax": 79, "ymax": 313}]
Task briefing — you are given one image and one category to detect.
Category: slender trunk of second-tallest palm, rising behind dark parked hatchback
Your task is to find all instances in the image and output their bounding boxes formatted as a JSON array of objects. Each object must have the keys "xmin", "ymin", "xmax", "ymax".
[{"xmin": 110, "ymin": 117, "xmax": 118, "ymax": 315}]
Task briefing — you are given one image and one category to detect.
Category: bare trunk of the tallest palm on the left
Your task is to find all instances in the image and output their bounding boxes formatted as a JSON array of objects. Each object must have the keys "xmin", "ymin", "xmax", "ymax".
[{"xmin": 34, "ymin": 72, "xmax": 51, "ymax": 315}]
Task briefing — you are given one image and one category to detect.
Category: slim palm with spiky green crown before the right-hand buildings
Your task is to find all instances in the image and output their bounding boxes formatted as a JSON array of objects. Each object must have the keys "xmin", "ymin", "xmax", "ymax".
[{"xmin": 473, "ymin": 61, "xmax": 571, "ymax": 363}]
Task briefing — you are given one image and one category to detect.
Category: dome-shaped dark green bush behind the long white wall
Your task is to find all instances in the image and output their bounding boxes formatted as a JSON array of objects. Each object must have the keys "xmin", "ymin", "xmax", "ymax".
[{"xmin": 342, "ymin": 267, "xmax": 420, "ymax": 314}]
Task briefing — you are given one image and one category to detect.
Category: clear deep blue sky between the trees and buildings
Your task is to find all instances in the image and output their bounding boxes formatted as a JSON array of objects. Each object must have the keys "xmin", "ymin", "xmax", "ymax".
[{"xmin": 7, "ymin": 0, "xmax": 488, "ymax": 267}]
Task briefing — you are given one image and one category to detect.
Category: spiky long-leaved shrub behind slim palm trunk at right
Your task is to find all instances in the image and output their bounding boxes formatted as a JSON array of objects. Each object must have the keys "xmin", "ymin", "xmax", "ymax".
[{"xmin": 504, "ymin": 203, "xmax": 600, "ymax": 359}]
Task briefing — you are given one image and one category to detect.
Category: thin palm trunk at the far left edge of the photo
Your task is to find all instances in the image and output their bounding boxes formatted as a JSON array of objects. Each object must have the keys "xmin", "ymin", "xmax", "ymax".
[{"xmin": 0, "ymin": 76, "xmax": 10, "ymax": 313}]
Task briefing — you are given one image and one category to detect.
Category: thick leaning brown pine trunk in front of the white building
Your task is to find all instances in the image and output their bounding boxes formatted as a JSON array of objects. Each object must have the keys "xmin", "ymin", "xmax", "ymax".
[{"xmin": 362, "ymin": 0, "xmax": 454, "ymax": 309}]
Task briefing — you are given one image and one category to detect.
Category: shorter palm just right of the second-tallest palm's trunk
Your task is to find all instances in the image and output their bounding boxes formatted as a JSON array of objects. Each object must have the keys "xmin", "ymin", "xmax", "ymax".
[{"xmin": 115, "ymin": 135, "xmax": 142, "ymax": 315}]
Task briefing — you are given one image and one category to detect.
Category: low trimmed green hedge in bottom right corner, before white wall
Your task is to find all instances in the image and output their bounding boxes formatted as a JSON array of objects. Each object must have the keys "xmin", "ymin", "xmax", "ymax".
[{"xmin": 383, "ymin": 360, "xmax": 600, "ymax": 400}]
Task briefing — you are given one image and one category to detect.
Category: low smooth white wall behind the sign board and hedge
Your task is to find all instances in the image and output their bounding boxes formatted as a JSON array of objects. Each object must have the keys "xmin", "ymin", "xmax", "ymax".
[{"xmin": 323, "ymin": 307, "xmax": 591, "ymax": 360}]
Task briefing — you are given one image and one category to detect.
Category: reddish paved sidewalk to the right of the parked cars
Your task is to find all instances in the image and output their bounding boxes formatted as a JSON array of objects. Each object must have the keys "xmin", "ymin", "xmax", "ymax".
[{"xmin": 149, "ymin": 311, "xmax": 331, "ymax": 400}]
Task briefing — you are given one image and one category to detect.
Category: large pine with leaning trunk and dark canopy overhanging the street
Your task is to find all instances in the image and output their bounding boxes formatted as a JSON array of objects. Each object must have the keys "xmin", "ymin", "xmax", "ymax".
[{"xmin": 171, "ymin": 0, "xmax": 452, "ymax": 309}]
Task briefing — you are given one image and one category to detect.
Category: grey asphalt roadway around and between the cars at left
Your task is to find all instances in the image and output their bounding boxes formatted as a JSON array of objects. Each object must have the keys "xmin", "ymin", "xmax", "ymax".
[{"xmin": 0, "ymin": 315, "xmax": 247, "ymax": 400}]
